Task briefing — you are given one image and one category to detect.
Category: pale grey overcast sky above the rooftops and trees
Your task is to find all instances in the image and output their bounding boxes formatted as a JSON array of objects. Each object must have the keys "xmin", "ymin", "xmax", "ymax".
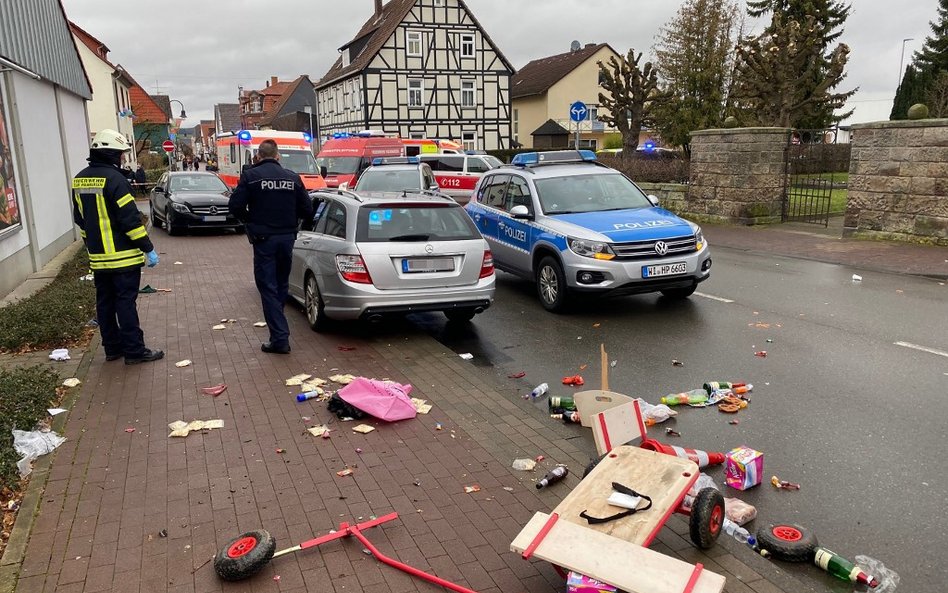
[{"xmin": 62, "ymin": 0, "xmax": 938, "ymax": 127}]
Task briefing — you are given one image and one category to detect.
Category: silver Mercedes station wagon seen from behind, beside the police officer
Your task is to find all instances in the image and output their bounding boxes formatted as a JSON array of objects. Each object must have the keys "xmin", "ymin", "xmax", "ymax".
[{"xmin": 289, "ymin": 190, "xmax": 494, "ymax": 331}]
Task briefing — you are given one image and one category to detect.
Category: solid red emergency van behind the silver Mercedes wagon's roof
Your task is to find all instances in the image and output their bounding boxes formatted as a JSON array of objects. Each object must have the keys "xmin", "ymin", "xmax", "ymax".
[{"xmin": 316, "ymin": 132, "xmax": 405, "ymax": 187}]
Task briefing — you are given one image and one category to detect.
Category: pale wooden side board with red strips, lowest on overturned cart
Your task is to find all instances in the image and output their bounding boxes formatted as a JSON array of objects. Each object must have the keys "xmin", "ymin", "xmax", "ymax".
[{"xmin": 510, "ymin": 508, "xmax": 725, "ymax": 593}]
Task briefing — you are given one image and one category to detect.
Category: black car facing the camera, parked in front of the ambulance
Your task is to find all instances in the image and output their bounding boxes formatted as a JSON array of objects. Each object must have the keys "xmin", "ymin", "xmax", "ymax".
[{"xmin": 148, "ymin": 171, "xmax": 243, "ymax": 235}]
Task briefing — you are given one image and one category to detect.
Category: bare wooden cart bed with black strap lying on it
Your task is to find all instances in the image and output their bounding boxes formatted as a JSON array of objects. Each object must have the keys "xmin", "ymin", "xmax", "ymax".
[{"xmin": 553, "ymin": 445, "xmax": 698, "ymax": 544}]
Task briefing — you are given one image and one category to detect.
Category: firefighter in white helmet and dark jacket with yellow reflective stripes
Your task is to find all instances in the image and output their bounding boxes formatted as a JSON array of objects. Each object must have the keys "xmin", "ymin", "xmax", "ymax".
[{"xmin": 72, "ymin": 130, "xmax": 165, "ymax": 364}]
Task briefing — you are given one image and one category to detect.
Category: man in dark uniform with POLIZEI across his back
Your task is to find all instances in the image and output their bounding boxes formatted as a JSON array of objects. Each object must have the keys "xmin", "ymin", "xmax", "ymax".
[{"xmin": 230, "ymin": 140, "xmax": 313, "ymax": 354}]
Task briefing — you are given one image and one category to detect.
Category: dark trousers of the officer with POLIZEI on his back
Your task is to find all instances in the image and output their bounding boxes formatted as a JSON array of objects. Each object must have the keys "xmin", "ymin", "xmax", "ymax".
[{"xmin": 253, "ymin": 235, "xmax": 296, "ymax": 348}]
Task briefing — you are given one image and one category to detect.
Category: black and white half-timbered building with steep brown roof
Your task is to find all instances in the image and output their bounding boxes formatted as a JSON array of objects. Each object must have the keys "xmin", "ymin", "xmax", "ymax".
[{"xmin": 316, "ymin": 0, "xmax": 514, "ymax": 150}]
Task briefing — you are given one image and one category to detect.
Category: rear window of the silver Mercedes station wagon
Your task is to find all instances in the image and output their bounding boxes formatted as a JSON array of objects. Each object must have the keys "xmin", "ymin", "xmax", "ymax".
[{"xmin": 356, "ymin": 204, "xmax": 481, "ymax": 242}]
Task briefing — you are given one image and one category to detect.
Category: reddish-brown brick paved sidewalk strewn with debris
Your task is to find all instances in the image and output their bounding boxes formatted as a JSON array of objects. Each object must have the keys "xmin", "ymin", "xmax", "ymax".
[{"xmin": 5, "ymin": 231, "xmax": 805, "ymax": 593}]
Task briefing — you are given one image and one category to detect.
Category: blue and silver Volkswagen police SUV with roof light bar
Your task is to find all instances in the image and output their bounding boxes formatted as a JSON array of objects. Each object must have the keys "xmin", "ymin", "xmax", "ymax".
[{"xmin": 466, "ymin": 150, "xmax": 711, "ymax": 311}]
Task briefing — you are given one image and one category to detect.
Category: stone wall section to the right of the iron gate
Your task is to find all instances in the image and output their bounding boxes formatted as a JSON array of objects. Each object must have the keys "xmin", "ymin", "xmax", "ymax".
[{"xmin": 843, "ymin": 119, "xmax": 948, "ymax": 245}]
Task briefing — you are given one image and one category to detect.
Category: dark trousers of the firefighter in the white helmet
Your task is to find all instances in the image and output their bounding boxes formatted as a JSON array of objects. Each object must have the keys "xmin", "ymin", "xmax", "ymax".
[{"xmin": 93, "ymin": 268, "xmax": 145, "ymax": 358}]
